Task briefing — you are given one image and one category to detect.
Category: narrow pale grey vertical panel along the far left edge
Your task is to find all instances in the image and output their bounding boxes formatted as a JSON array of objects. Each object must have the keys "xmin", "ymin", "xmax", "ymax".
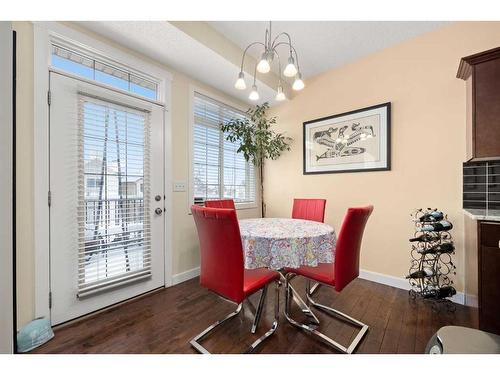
[{"xmin": 0, "ymin": 22, "xmax": 14, "ymax": 353}]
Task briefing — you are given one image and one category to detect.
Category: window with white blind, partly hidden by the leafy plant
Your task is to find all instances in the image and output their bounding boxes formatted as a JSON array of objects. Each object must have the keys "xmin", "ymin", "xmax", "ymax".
[{"xmin": 192, "ymin": 92, "xmax": 256, "ymax": 205}]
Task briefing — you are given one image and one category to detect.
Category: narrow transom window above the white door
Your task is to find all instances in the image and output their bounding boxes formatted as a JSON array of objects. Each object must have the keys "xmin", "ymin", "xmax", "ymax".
[{"xmin": 51, "ymin": 44, "xmax": 158, "ymax": 100}]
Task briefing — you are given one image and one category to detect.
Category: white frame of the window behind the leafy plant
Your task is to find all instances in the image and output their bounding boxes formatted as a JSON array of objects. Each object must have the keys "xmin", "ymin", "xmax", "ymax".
[{"xmin": 187, "ymin": 85, "xmax": 260, "ymax": 214}]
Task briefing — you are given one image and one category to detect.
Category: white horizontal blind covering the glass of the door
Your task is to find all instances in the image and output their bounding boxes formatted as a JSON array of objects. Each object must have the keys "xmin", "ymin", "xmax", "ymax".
[{"xmin": 78, "ymin": 94, "xmax": 151, "ymax": 298}]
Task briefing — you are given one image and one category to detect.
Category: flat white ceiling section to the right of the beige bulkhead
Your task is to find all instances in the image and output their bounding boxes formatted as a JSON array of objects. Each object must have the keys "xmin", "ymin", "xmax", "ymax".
[{"xmin": 209, "ymin": 21, "xmax": 446, "ymax": 78}]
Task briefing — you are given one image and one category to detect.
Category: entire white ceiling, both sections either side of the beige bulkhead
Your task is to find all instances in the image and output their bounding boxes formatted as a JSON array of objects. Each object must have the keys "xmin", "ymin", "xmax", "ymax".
[{"xmin": 77, "ymin": 21, "xmax": 446, "ymax": 104}]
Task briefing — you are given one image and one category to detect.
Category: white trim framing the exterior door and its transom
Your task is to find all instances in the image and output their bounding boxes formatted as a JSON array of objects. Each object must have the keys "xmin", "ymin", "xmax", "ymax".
[{"xmin": 33, "ymin": 22, "xmax": 173, "ymax": 318}]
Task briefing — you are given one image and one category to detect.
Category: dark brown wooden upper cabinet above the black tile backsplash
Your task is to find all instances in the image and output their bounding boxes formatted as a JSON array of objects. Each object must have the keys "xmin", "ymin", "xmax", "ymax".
[{"xmin": 457, "ymin": 47, "xmax": 500, "ymax": 160}]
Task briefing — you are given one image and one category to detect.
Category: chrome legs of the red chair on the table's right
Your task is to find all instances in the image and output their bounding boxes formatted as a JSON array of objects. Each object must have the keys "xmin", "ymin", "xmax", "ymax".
[{"xmin": 285, "ymin": 280, "xmax": 369, "ymax": 354}]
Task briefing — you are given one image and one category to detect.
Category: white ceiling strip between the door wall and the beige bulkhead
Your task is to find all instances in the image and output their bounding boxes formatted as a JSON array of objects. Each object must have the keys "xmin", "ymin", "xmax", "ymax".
[{"xmin": 77, "ymin": 21, "xmax": 276, "ymax": 104}]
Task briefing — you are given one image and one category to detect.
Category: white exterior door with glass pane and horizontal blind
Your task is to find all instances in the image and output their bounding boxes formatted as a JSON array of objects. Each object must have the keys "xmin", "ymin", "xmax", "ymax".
[{"xmin": 49, "ymin": 72, "xmax": 165, "ymax": 325}]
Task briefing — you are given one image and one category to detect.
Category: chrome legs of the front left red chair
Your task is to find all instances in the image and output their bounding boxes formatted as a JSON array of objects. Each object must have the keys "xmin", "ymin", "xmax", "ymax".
[{"xmin": 190, "ymin": 281, "xmax": 281, "ymax": 354}]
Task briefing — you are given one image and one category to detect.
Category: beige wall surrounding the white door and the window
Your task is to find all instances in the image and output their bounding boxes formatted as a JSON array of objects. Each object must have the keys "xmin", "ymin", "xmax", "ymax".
[{"xmin": 14, "ymin": 22, "xmax": 259, "ymax": 326}]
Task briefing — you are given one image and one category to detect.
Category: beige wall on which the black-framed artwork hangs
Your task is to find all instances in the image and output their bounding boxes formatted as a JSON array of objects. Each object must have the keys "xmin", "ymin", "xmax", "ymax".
[{"xmin": 264, "ymin": 22, "xmax": 500, "ymax": 296}]
